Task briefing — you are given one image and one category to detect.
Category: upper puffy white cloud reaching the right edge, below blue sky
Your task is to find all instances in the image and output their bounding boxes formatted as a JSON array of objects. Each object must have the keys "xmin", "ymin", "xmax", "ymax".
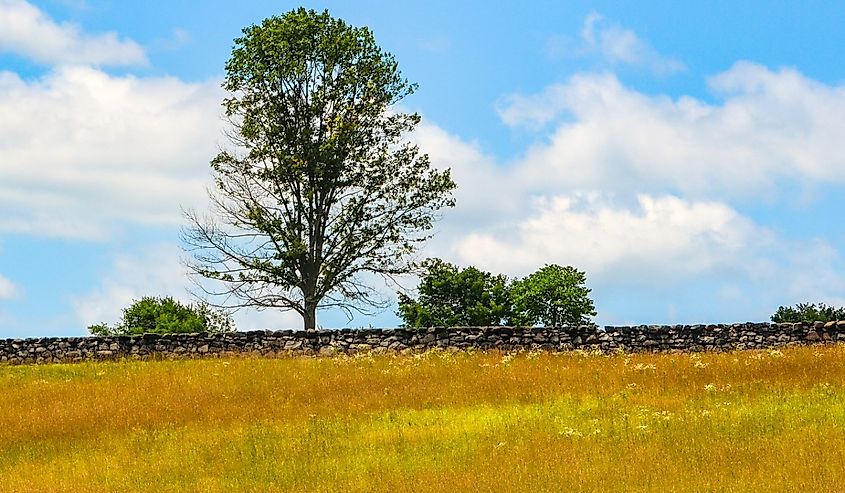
[{"xmin": 500, "ymin": 62, "xmax": 845, "ymax": 198}]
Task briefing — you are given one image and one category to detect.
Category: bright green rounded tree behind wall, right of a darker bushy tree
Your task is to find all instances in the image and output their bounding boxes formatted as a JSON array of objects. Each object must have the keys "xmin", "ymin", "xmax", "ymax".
[{"xmin": 511, "ymin": 264, "xmax": 596, "ymax": 327}]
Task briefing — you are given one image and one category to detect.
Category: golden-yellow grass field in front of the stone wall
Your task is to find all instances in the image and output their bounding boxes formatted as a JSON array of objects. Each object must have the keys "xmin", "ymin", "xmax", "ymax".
[{"xmin": 0, "ymin": 345, "xmax": 845, "ymax": 492}]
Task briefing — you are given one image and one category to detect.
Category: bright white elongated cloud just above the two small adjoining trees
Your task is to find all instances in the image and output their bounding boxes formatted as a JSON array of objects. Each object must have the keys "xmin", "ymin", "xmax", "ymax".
[{"xmin": 455, "ymin": 193, "xmax": 771, "ymax": 283}]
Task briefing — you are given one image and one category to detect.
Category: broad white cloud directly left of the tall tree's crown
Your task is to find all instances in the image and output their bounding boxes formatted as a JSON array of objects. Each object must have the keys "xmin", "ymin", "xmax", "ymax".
[{"xmin": 0, "ymin": 67, "xmax": 223, "ymax": 238}]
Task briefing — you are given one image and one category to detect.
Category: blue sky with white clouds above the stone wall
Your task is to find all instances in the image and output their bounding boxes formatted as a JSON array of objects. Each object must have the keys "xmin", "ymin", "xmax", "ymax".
[{"xmin": 0, "ymin": 0, "xmax": 845, "ymax": 338}]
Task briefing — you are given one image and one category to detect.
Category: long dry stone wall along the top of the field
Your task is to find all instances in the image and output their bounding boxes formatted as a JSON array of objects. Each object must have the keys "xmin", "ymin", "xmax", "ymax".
[{"xmin": 0, "ymin": 321, "xmax": 845, "ymax": 364}]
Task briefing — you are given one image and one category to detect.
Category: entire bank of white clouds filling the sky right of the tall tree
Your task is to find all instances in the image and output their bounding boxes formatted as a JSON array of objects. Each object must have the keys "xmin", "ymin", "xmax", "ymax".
[{"xmin": 419, "ymin": 62, "xmax": 845, "ymax": 323}]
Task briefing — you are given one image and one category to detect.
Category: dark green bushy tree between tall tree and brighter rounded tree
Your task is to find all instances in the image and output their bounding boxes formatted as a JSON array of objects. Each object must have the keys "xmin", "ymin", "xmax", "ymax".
[{"xmin": 398, "ymin": 259, "xmax": 521, "ymax": 327}]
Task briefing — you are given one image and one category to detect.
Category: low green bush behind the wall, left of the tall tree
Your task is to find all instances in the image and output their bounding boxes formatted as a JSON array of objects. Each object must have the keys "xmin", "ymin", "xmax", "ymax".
[{"xmin": 88, "ymin": 296, "xmax": 234, "ymax": 336}]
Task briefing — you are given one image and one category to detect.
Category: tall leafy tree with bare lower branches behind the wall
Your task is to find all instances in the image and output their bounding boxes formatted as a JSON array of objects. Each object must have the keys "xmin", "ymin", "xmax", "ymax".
[{"xmin": 184, "ymin": 8, "xmax": 455, "ymax": 329}]
